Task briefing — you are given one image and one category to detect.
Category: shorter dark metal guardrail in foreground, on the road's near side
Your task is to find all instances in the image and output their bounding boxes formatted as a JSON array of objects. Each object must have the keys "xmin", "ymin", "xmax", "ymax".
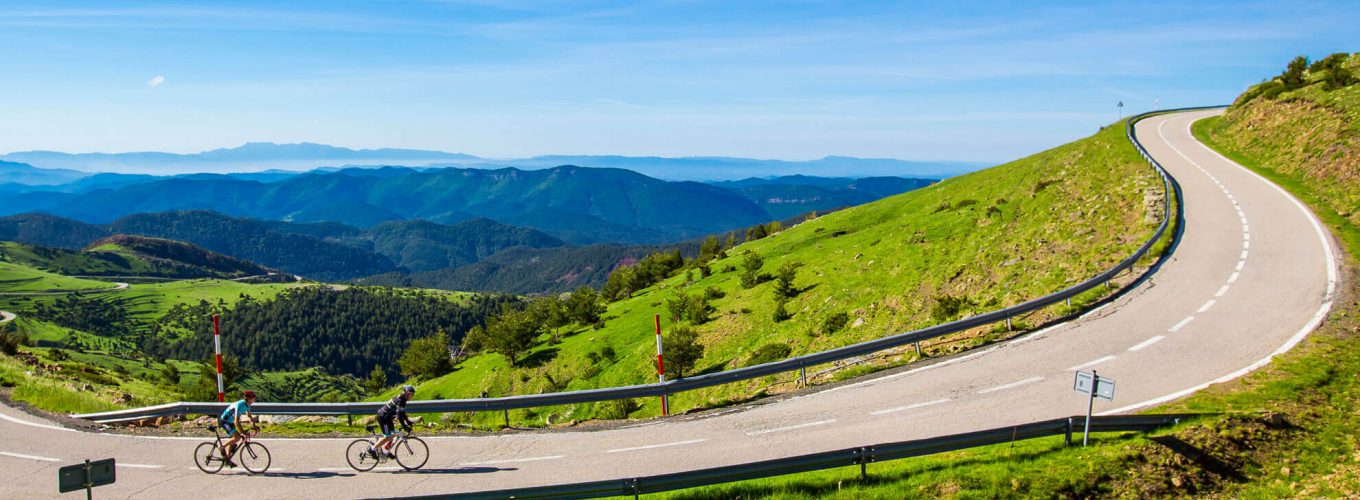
[{"xmin": 394, "ymin": 414, "xmax": 1204, "ymax": 499}]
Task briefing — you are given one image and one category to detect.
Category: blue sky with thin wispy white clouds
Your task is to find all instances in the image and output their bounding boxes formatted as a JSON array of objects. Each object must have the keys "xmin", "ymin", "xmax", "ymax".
[{"xmin": 0, "ymin": 0, "xmax": 1360, "ymax": 162}]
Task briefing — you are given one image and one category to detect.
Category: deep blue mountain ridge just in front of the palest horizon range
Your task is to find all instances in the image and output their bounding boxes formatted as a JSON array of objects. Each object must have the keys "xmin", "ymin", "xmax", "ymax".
[{"xmin": 0, "ymin": 166, "xmax": 932, "ymax": 245}]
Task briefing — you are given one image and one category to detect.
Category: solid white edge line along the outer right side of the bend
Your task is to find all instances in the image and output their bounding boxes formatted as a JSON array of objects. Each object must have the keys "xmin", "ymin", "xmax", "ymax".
[{"xmin": 1099, "ymin": 112, "xmax": 1337, "ymax": 414}]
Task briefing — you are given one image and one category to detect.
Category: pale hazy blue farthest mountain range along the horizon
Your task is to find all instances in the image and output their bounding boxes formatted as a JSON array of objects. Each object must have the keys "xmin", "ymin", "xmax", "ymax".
[{"xmin": 0, "ymin": 143, "xmax": 987, "ymax": 179}]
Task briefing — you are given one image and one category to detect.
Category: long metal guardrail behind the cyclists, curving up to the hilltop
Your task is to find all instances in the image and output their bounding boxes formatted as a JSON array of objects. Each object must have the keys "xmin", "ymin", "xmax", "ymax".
[{"xmin": 72, "ymin": 106, "xmax": 1221, "ymax": 424}]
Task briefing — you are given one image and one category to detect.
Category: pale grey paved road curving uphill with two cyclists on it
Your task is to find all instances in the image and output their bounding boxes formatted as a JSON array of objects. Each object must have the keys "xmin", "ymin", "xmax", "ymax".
[{"xmin": 0, "ymin": 111, "xmax": 1337, "ymax": 499}]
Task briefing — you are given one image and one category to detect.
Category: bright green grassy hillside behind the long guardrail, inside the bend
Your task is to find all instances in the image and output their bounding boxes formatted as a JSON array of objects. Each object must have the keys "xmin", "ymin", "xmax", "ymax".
[{"xmin": 419, "ymin": 122, "xmax": 1161, "ymax": 424}]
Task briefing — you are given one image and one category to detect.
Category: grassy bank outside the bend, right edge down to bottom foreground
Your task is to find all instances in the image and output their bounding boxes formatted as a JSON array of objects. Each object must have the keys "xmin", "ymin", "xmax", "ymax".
[{"xmin": 655, "ymin": 56, "xmax": 1360, "ymax": 499}]
